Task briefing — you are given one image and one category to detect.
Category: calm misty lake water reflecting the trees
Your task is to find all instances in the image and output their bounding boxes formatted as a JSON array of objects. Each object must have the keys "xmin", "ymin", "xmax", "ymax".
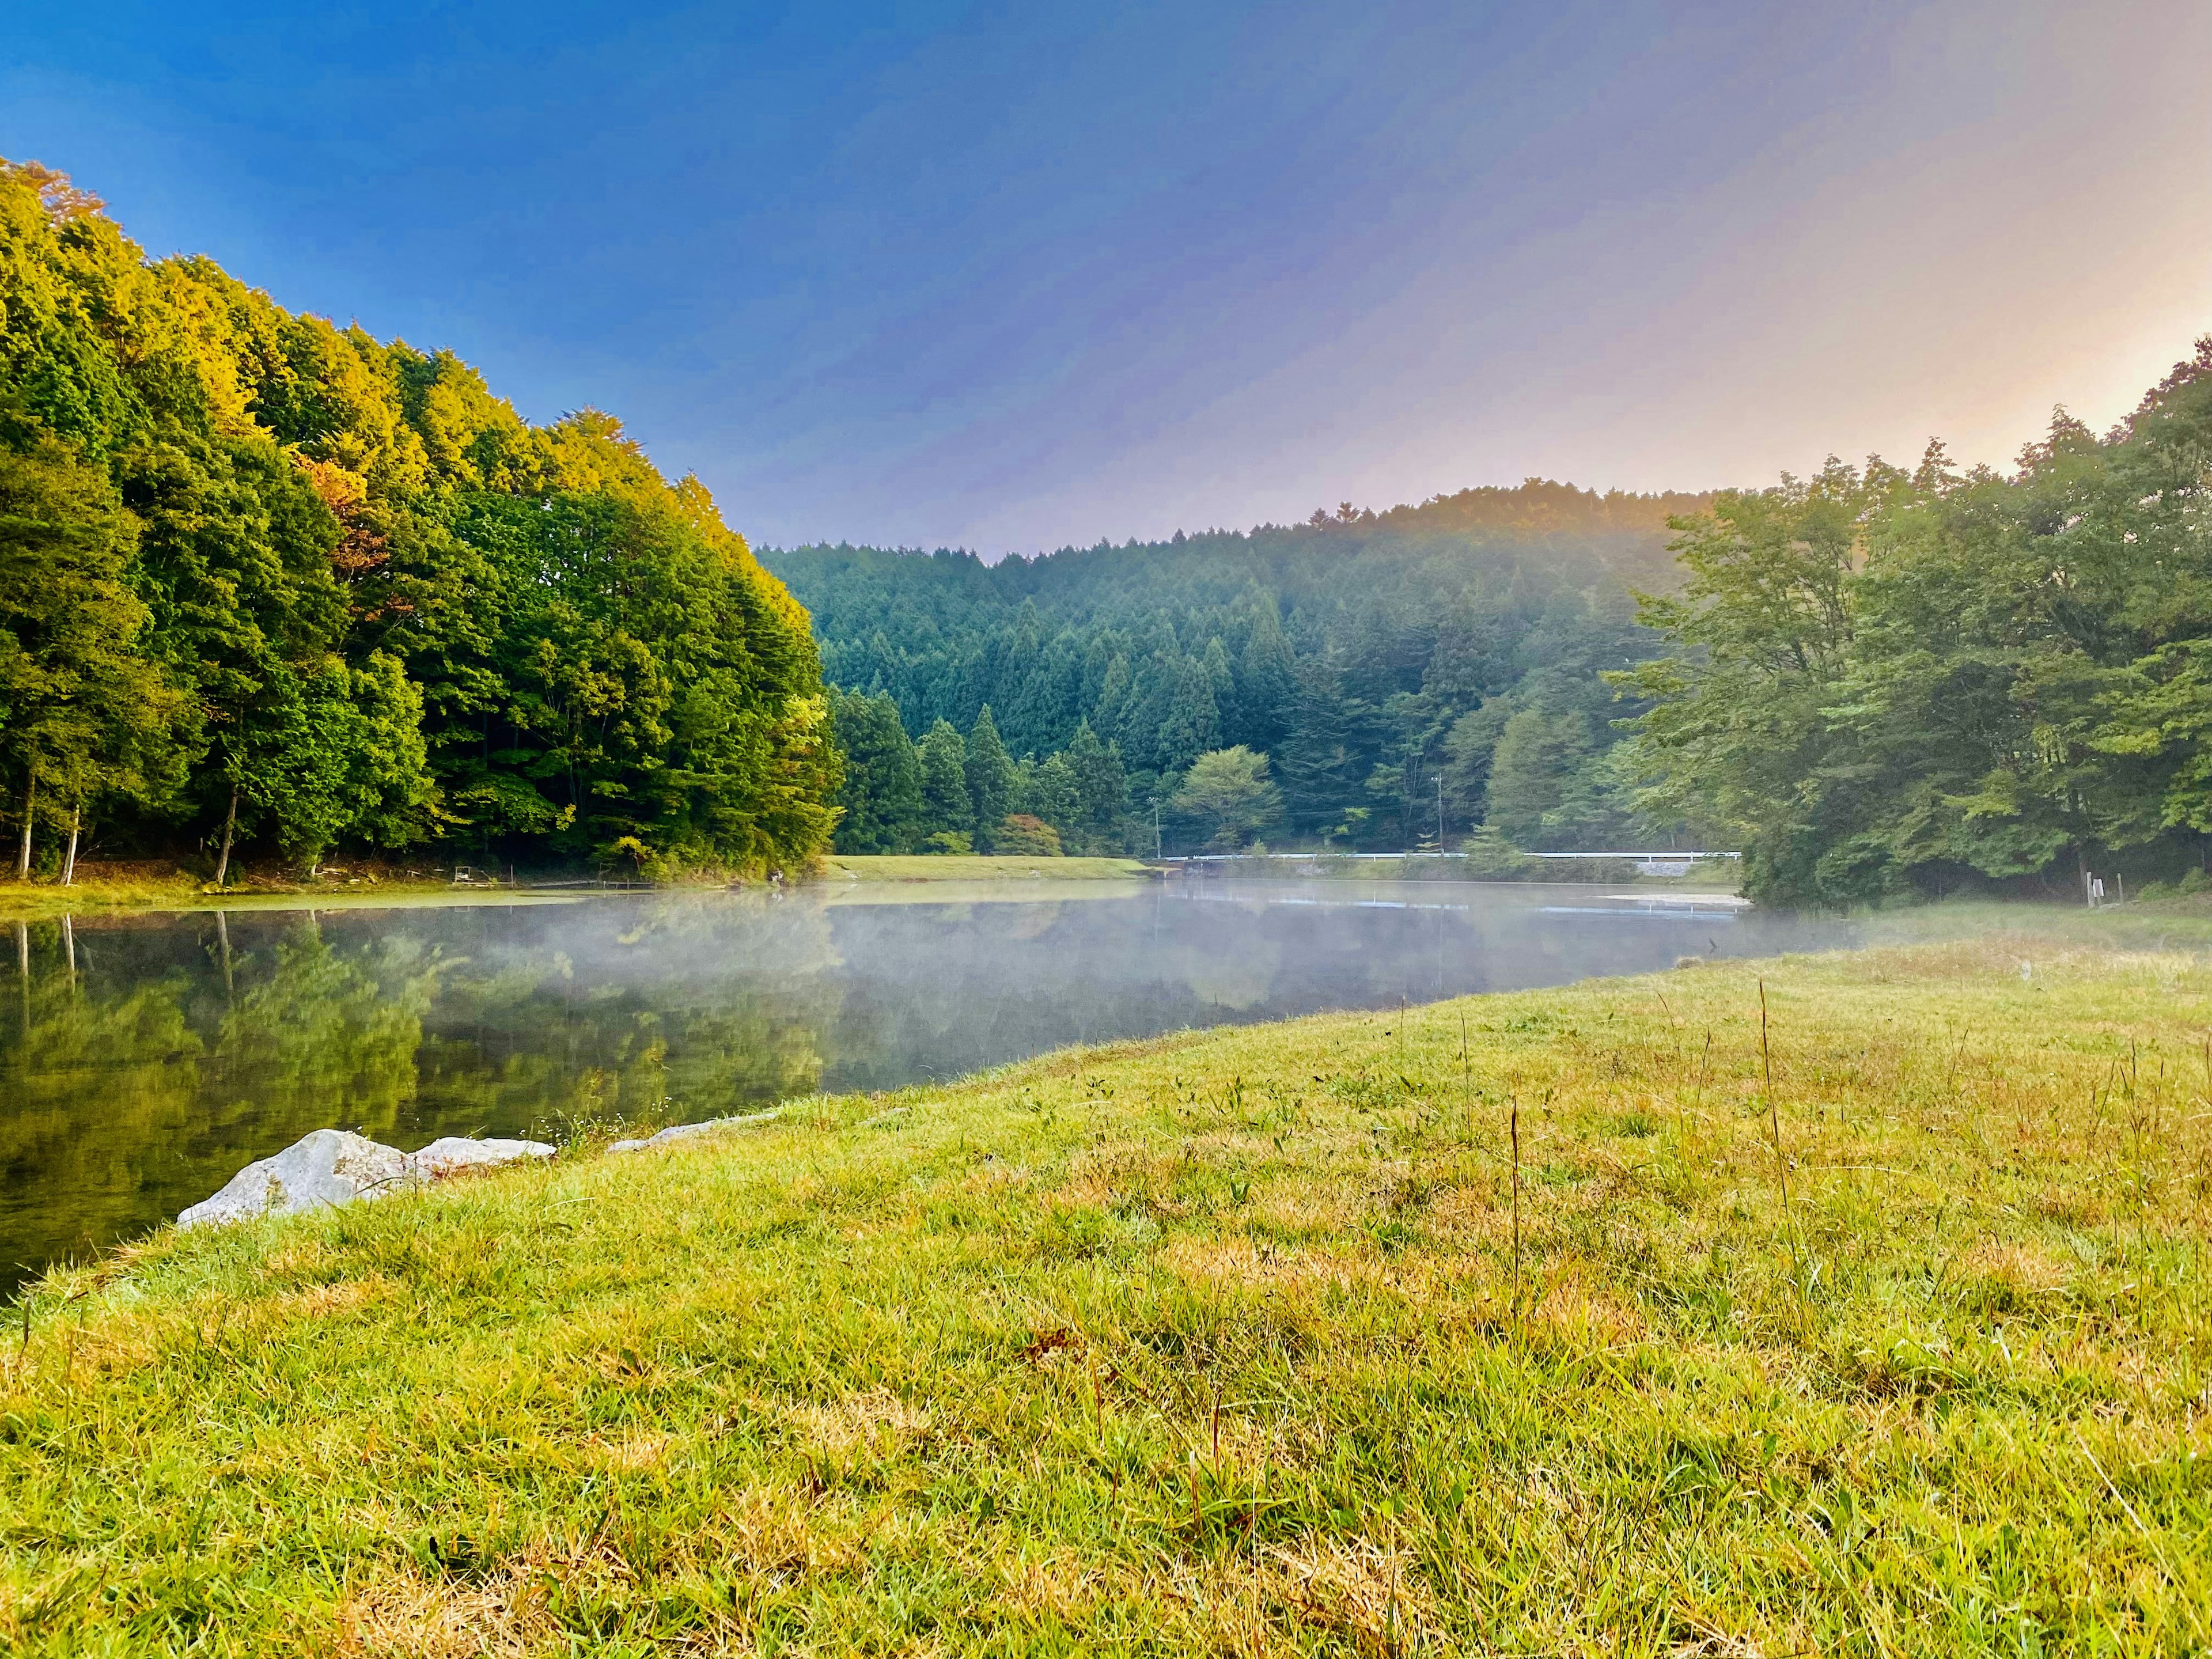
[{"xmin": 0, "ymin": 880, "xmax": 1845, "ymax": 1294}]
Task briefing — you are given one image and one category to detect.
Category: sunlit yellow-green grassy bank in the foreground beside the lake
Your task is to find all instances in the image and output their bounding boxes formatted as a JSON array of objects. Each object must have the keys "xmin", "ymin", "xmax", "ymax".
[{"xmin": 0, "ymin": 933, "xmax": 2212, "ymax": 1659}]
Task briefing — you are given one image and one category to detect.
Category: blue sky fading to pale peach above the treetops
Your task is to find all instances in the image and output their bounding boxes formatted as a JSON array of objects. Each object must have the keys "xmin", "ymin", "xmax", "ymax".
[{"xmin": 0, "ymin": 0, "xmax": 2212, "ymax": 558}]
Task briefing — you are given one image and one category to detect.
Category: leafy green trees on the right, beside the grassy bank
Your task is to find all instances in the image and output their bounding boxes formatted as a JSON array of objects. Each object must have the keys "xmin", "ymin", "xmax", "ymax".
[{"xmin": 1612, "ymin": 339, "xmax": 2212, "ymax": 905}]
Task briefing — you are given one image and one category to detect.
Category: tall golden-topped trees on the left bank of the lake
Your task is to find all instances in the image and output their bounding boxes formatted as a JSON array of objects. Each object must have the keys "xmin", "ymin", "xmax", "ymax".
[{"xmin": 0, "ymin": 161, "xmax": 838, "ymax": 878}]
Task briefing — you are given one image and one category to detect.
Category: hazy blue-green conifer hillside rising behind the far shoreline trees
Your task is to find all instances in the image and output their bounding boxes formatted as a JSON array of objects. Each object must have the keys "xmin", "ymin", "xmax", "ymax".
[{"xmin": 767, "ymin": 480, "xmax": 1706, "ymax": 851}]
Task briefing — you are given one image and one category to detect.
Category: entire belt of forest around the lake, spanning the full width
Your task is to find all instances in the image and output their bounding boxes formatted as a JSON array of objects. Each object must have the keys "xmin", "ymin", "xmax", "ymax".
[{"xmin": 0, "ymin": 161, "xmax": 2212, "ymax": 907}]
